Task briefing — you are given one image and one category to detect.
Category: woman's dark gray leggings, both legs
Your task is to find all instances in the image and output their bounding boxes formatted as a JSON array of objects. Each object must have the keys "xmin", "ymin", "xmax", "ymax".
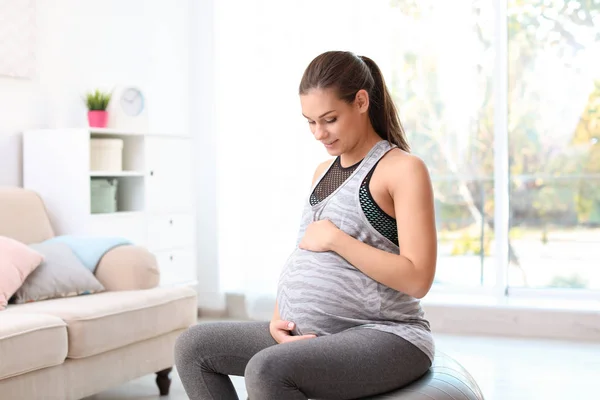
[{"xmin": 175, "ymin": 322, "xmax": 431, "ymax": 400}]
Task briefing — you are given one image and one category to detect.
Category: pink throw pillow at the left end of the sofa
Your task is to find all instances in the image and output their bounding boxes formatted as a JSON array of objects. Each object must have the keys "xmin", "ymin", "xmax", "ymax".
[{"xmin": 0, "ymin": 236, "xmax": 44, "ymax": 311}]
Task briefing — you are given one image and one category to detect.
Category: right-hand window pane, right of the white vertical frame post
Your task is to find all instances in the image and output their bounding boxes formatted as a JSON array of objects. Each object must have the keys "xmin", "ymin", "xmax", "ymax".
[{"xmin": 508, "ymin": 0, "xmax": 600, "ymax": 289}]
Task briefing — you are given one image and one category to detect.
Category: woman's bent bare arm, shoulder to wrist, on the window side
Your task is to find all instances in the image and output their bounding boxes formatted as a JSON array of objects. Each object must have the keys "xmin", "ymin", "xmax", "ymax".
[{"xmin": 328, "ymin": 154, "xmax": 437, "ymax": 298}]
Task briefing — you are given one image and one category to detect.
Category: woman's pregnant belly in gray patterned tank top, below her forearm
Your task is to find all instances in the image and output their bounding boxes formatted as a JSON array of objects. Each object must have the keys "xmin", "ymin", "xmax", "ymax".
[{"xmin": 277, "ymin": 249, "xmax": 381, "ymax": 336}]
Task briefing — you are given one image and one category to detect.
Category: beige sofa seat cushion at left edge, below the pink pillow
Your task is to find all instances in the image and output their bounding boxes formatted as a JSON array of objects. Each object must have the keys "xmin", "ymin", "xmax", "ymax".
[{"xmin": 0, "ymin": 312, "xmax": 68, "ymax": 380}]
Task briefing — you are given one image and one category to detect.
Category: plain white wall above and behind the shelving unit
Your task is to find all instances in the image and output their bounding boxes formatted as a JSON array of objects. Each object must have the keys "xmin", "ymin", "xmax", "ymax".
[{"xmin": 0, "ymin": 0, "xmax": 190, "ymax": 186}]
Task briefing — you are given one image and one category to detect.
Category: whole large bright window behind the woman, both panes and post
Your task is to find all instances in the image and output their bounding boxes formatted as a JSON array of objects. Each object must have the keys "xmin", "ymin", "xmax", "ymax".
[{"xmin": 388, "ymin": 0, "xmax": 600, "ymax": 289}]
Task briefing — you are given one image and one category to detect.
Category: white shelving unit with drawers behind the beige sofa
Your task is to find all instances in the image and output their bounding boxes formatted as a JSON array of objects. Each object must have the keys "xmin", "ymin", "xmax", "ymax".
[{"xmin": 23, "ymin": 128, "xmax": 197, "ymax": 286}]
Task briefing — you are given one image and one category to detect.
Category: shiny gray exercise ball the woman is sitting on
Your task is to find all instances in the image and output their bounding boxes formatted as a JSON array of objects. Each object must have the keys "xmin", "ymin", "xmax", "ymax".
[{"xmin": 363, "ymin": 351, "xmax": 483, "ymax": 400}]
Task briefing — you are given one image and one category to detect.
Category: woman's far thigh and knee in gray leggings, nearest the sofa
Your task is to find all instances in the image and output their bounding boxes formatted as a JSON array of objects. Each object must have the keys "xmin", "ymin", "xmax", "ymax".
[{"xmin": 175, "ymin": 321, "xmax": 277, "ymax": 376}]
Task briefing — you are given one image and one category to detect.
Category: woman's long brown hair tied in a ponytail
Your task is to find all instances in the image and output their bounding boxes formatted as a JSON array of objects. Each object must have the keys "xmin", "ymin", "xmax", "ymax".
[{"xmin": 299, "ymin": 51, "xmax": 410, "ymax": 151}]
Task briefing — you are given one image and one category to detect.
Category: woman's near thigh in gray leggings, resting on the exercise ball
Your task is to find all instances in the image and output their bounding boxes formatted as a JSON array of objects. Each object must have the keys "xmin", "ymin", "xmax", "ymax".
[{"xmin": 246, "ymin": 328, "xmax": 431, "ymax": 399}]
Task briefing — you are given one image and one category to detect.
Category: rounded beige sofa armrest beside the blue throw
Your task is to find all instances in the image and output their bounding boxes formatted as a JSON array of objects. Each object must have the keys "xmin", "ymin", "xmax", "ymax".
[{"xmin": 95, "ymin": 245, "xmax": 160, "ymax": 291}]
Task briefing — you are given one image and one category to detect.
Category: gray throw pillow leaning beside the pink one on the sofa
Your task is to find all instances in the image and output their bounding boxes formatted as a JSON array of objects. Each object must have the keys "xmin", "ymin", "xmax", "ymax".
[{"xmin": 15, "ymin": 241, "xmax": 104, "ymax": 304}]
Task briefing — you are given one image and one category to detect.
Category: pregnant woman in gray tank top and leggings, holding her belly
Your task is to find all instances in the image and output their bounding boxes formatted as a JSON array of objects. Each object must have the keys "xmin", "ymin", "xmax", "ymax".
[{"xmin": 175, "ymin": 51, "xmax": 437, "ymax": 400}]
